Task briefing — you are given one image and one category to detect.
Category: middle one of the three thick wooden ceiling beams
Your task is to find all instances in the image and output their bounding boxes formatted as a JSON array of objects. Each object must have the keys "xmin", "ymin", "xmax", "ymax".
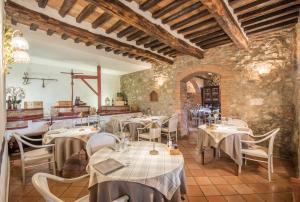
[{"xmin": 86, "ymin": 0, "xmax": 203, "ymax": 58}]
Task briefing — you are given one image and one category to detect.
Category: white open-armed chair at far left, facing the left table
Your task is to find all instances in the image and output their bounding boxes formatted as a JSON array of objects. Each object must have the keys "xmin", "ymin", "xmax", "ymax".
[{"xmin": 13, "ymin": 133, "xmax": 56, "ymax": 183}]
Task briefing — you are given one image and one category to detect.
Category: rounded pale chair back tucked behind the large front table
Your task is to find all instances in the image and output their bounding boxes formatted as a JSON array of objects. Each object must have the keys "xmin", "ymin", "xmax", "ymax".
[{"xmin": 86, "ymin": 132, "xmax": 120, "ymax": 157}]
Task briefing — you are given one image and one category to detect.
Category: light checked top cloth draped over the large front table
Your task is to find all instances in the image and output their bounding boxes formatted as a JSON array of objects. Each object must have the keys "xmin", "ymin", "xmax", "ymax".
[{"xmin": 87, "ymin": 141, "xmax": 185, "ymax": 201}]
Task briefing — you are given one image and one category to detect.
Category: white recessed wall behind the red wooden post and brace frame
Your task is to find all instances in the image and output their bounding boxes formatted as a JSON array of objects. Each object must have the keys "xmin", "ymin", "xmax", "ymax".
[{"xmin": 6, "ymin": 64, "xmax": 120, "ymax": 114}]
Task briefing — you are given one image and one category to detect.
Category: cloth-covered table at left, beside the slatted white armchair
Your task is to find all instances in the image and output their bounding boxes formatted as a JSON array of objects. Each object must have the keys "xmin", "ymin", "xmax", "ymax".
[{"xmin": 42, "ymin": 126, "xmax": 99, "ymax": 171}]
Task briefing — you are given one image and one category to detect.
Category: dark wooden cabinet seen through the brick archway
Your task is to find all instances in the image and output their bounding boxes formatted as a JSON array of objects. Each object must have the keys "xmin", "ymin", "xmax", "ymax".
[{"xmin": 202, "ymin": 86, "xmax": 220, "ymax": 108}]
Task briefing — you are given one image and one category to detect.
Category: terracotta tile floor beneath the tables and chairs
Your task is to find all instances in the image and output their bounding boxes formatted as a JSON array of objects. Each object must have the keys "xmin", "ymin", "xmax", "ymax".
[{"xmin": 9, "ymin": 134, "xmax": 300, "ymax": 202}]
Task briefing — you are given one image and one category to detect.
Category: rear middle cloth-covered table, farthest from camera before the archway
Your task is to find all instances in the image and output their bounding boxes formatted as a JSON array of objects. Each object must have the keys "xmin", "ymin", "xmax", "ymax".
[{"xmin": 119, "ymin": 116, "xmax": 168, "ymax": 140}]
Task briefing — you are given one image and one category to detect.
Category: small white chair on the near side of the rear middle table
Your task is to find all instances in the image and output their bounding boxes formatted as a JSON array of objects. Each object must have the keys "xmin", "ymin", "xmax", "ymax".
[{"xmin": 137, "ymin": 124, "xmax": 161, "ymax": 142}]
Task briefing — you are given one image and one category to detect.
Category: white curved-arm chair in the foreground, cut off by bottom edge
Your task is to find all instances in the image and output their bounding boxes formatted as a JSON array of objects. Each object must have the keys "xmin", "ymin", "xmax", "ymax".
[{"xmin": 32, "ymin": 173, "xmax": 129, "ymax": 202}]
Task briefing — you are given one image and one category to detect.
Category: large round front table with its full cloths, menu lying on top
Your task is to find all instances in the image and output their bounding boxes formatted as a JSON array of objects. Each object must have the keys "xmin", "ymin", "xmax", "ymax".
[{"xmin": 87, "ymin": 141, "xmax": 186, "ymax": 202}]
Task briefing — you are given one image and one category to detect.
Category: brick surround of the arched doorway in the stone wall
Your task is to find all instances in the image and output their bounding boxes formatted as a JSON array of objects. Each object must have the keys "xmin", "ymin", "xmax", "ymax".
[{"xmin": 175, "ymin": 65, "xmax": 234, "ymax": 136}]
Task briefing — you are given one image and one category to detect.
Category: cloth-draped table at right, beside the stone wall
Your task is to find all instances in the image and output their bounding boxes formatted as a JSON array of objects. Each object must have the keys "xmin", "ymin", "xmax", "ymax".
[{"xmin": 197, "ymin": 123, "xmax": 253, "ymax": 174}]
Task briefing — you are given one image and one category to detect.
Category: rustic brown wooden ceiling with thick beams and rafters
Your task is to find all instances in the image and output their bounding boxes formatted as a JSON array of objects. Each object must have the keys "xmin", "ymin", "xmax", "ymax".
[{"xmin": 6, "ymin": 0, "xmax": 300, "ymax": 63}]
